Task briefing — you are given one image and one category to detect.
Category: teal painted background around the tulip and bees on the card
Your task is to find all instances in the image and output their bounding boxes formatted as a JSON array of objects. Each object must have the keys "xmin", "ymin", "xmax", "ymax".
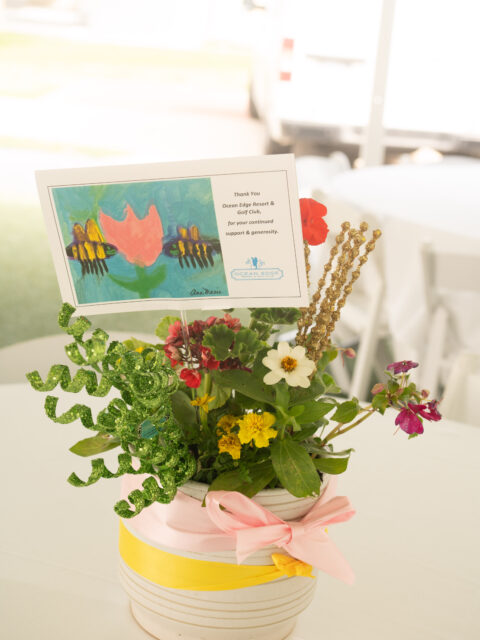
[{"xmin": 52, "ymin": 178, "xmax": 228, "ymax": 304}]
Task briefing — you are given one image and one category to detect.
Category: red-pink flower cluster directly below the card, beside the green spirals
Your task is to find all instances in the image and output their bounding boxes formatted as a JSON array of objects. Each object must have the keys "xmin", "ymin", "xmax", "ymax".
[{"xmin": 164, "ymin": 313, "xmax": 243, "ymax": 389}]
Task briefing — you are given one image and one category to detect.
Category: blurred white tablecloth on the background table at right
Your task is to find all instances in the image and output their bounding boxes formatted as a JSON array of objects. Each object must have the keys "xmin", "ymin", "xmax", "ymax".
[{"xmin": 329, "ymin": 161, "xmax": 480, "ymax": 359}]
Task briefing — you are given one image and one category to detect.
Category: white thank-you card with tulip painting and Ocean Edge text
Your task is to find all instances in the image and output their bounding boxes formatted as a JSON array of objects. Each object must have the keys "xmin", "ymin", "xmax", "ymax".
[{"xmin": 37, "ymin": 154, "xmax": 308, "ymax": 314}]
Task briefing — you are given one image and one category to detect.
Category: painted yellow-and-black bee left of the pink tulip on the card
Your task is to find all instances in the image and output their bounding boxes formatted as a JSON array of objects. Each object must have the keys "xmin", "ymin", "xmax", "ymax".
[{"xmin": 66, "ymin": 218, "xmax": 117, "ymax": 276}]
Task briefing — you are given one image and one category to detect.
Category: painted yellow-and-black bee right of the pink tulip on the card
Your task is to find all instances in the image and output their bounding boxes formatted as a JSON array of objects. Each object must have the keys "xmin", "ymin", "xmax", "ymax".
[{"xmin": 163, "ymin": 224, "xmax": 221, "ymax": 269}]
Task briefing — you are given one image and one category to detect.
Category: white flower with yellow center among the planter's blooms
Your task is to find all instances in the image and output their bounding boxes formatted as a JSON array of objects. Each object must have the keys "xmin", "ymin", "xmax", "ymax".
[{"xmin": 262, "ymin": 342, "xmax": 315, "ymax": 389}]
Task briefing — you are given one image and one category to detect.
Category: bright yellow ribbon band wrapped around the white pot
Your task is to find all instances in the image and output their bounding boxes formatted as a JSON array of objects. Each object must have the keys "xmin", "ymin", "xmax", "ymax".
[{"xmin": 119, "ymin": 521, "xmax": 311, "ymax": 591}]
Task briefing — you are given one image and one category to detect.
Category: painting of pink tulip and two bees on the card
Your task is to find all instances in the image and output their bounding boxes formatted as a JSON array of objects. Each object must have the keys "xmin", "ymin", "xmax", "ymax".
[{"xmin": 52, "ymin": 178, "xmax": 228, "ymax": 304}]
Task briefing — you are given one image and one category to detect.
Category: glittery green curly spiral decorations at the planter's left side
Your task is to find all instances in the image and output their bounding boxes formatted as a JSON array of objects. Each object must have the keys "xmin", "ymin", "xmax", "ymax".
[{"xmin": 27, "ymin": 304, "xmax": 196, "ymax": 517}]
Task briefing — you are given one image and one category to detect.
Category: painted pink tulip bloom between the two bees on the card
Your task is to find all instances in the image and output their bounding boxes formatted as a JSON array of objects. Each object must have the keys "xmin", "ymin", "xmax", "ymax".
[{"xmin": 99, "ymin": 204, "xmax": 163, "ymax": 267}]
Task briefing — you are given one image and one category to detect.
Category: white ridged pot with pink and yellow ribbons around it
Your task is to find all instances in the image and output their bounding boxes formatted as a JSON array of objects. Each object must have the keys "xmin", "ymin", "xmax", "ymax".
[{"xmin": 120, "ymin": 482, "xmax": 325, "ymax": 640}]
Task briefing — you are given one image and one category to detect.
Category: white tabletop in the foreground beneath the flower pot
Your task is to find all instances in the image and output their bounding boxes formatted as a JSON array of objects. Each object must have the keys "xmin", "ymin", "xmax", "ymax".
[{"xmin": 0, "ymin": 380, "xmax": 480, "ymax": 640}]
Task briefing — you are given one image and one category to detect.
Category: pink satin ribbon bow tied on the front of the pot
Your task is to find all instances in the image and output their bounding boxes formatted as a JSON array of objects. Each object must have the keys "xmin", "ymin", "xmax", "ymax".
[{"xmin": 206, "ymin": 480, "xmax": 355, "ymax": 584}]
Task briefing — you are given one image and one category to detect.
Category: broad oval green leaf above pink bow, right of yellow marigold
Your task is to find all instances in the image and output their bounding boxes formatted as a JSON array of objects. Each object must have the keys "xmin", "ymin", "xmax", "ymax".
[{"xmin": 271, "ymin": 436, "xmax": 320, "ymax": 498}]
